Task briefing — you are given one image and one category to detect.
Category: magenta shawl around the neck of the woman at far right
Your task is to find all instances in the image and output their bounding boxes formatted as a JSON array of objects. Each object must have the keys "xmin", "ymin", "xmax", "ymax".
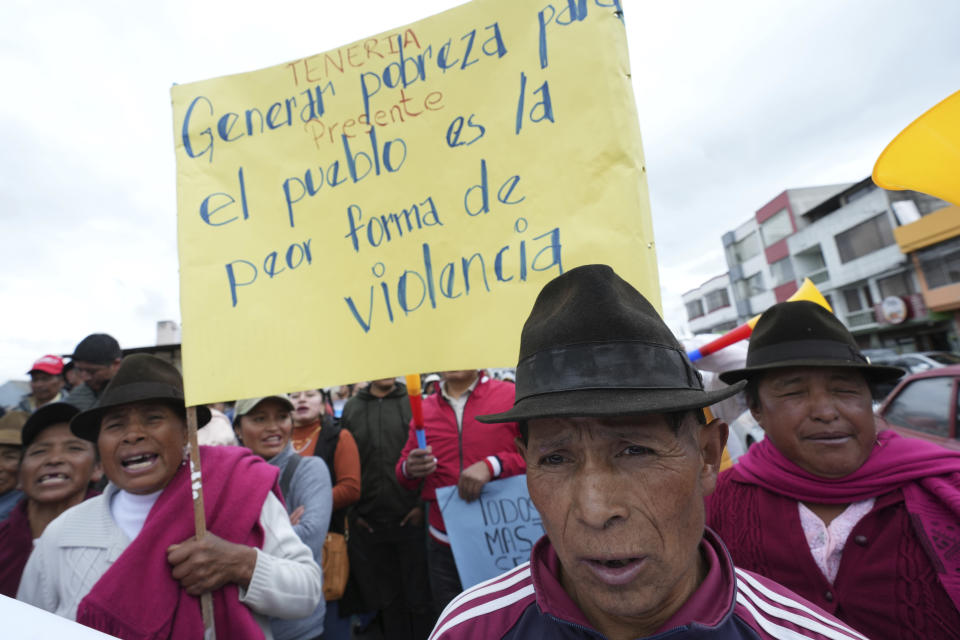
[{"xmin": 734, "ymin": 431, "xmax": 960, "ymax": 610}]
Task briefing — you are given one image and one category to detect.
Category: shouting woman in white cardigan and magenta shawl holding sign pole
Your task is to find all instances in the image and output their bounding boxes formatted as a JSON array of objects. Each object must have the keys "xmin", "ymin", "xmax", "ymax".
[{"xmin": 17, "ymin": 355, "xmax": 322, "ymax": 638}]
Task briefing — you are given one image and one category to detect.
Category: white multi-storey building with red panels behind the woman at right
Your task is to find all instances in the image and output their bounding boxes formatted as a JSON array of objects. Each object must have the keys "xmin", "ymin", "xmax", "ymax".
[{"xmin": 704, "ymin": 177, "xmax": 955, "ymax": 352}]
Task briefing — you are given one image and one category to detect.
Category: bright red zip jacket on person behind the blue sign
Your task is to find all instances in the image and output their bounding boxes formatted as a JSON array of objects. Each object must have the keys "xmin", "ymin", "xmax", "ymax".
[{"xmin": 395, "ymin": 377, "xmax": 526, "ymax": 542}]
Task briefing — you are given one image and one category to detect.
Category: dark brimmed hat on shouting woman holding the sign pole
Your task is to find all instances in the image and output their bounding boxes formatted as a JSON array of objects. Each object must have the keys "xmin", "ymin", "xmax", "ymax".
[{"xmin": 70, "ymin": 353, "xmax": 210, "ymax": 442}]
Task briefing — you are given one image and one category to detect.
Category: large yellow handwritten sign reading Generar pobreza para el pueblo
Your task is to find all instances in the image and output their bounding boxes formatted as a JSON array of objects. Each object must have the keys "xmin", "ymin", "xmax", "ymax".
[{"xmin": 171, "ymin": 0, "xmax": 659, "ymax": 404}]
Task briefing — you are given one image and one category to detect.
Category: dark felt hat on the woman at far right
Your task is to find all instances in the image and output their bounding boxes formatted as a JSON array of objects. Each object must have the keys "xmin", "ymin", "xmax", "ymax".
[{"xmin": 720, "ymin": 300, "xmax": 905, "ymax": 384}]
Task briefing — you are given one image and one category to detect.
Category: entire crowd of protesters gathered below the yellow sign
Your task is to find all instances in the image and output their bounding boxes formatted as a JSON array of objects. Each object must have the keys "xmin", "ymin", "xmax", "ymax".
[{"xmin": 0, "ymin": 265, "xmax": 960, "ymax": 640}]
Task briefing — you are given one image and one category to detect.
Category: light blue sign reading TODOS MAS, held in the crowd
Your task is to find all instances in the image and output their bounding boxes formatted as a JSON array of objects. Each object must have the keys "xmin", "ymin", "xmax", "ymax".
[{"xmin": 437, "ymin": 475, "xmax": 544, "ymax": 589}]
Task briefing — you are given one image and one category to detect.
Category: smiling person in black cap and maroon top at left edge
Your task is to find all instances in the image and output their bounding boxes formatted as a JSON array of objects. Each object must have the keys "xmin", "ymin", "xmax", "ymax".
[{"xmin": 0, "ymin": 402, "xmax": 100, "ymax": 598}]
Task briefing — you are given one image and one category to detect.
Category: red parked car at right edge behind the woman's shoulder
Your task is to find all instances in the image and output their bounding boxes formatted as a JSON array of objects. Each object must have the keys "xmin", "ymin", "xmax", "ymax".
[{"xmin": 877, "ymin": 364, "xmax": 960, "ymax": 451}]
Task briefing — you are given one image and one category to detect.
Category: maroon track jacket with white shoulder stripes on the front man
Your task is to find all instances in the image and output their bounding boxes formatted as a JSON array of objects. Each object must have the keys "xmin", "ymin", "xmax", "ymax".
[{"xmin": 430, "ymin": 529, "xmax": 864, "ymax": 640}]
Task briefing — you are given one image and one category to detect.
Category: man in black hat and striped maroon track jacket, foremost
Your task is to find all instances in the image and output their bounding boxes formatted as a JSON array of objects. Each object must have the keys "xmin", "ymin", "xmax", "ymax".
[{"xmin": 432, "ymin": 265, "xmax": 859, "ymax": 640}]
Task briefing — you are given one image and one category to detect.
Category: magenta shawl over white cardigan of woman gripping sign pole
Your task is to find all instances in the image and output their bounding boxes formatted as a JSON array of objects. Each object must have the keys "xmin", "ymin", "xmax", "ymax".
[{"xmin": 77, "ymin": 447, "xmax": 279, "ymax": 640}]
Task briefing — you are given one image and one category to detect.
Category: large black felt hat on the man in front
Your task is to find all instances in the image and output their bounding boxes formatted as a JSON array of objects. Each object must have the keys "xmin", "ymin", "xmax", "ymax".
[{"xmin": 477, "ymin": 265, "xmax": 743, "ymax": 422}]
